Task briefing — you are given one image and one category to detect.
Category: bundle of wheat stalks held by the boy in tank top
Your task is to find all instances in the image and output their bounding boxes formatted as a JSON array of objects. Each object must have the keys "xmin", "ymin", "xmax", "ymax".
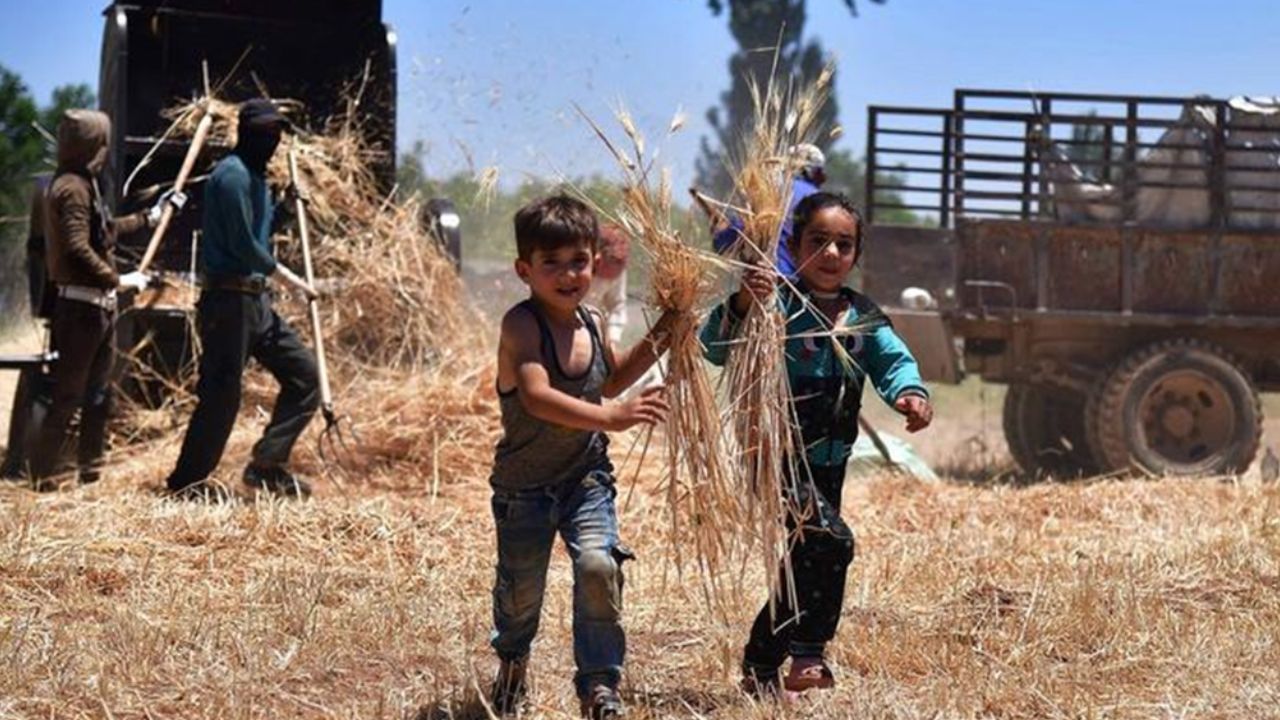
[{"xmin": 579, "ymin": 108, "xmax": 741, "ymax": 606}]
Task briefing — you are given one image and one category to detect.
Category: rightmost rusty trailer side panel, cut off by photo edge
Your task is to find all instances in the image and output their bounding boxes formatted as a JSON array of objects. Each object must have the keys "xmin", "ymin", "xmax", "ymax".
[{"xmin": 1219, "ymin": 234, "xmax": 1280, "ymax": 318}]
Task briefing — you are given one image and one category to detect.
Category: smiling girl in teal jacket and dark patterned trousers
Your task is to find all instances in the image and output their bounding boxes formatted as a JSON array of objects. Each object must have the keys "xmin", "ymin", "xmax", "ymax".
[{"xmin": 701, "ymin": 192, "xmax": 933, "ymax": 693}]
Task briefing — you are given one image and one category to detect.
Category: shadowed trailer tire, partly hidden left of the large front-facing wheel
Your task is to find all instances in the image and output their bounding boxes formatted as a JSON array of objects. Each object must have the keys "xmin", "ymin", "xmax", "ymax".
[{"xmin": 1004, "ymin": 384, "xmax": 1098, "ymax": 478}]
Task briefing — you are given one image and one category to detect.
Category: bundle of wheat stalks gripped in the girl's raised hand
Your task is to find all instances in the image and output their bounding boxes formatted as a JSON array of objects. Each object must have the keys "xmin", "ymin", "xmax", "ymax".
[{"xmin": 722, "ymin": 65, "xmax": 835, "ymax": 607}]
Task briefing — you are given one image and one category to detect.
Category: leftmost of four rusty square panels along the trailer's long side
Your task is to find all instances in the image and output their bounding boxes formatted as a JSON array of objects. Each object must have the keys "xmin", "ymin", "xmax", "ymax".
[{"xmin": 957, "ymin": 220, "xmax": 1041, "ymax": 310}]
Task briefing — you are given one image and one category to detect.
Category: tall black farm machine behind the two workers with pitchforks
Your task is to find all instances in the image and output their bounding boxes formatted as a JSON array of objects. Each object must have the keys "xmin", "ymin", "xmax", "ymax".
[{"xmin": 5, "ymin": 0, "xmax": 461, "ymax": 474}]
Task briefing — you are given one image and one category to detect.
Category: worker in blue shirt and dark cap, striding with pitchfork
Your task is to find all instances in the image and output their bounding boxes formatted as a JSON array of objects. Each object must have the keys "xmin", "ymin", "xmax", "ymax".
[{"xmin": 166, "ymin": 100, "xmax": 320, "ymax": 501}]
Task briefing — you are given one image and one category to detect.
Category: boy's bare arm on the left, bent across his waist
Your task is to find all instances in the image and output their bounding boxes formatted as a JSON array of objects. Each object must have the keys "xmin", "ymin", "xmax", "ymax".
[{"xmin": 499, "ymin": 309, "xmax": 666, "ymax": 430}]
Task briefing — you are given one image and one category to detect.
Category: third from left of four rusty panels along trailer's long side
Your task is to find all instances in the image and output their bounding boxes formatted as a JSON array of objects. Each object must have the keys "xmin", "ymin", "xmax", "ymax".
[{"xmin": 1133, "ymin": 231, "xmax": 1213, "ymax": 315}]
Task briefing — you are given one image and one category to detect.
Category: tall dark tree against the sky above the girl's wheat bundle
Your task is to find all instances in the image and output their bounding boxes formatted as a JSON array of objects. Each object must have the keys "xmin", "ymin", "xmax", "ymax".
[{"xmin": 696, "ymin": 0, "xmax": 884, "ymax": 195}]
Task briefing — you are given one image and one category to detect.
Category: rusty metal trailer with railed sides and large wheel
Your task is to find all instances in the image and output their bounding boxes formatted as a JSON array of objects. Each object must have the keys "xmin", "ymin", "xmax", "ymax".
[{"xmin": 865, "ymin": 90, "xmax": 1280, "ymax": 477}]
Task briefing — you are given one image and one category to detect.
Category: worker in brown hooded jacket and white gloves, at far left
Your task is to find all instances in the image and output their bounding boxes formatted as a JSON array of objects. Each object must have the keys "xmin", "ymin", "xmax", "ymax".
[{"xmin": 31, "ymin": 110, "xmax": 186, "ymax": 489}]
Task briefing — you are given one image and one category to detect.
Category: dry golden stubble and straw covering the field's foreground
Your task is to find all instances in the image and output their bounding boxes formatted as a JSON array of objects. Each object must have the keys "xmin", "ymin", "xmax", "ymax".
[{"xmin": 0, "ymin": 464, "xmax": 1280, "ymax": 719}]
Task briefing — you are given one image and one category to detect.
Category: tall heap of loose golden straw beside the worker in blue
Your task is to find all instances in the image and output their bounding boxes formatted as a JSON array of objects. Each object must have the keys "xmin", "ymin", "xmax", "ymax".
[{"xmin": 145, "ymin": 89, "xmax": 497, "ymax": 478}]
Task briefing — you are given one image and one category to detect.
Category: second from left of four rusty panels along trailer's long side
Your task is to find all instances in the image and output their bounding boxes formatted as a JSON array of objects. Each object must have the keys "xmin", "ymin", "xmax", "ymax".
[{"xmin": 1047, "ymin": 225, "xmax": 1121, "ymax": 311}]
